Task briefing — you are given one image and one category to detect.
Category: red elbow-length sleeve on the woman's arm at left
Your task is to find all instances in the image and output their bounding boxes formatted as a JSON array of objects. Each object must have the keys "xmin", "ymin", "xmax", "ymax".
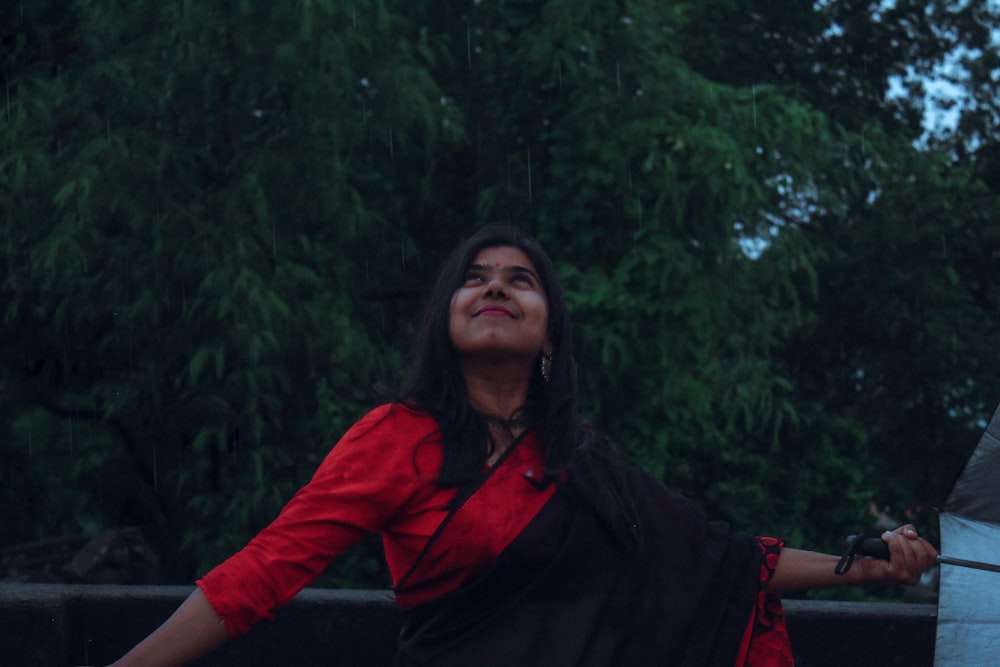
[{"xmin": 197, "ymin": 405, "xmax": 440, "ymax": 637}]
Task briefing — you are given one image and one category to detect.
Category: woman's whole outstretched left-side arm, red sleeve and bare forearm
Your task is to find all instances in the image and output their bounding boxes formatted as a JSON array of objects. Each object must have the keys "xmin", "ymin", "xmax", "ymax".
[{"xmin": 113, "ymin": 406, "xmax": 430, "ymax": 667}]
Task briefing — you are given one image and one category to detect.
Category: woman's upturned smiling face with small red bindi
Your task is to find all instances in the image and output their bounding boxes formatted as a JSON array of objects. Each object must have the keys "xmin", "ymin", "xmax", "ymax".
[{"xmin": 448, "ymin": 246, "xmax": 549, "ymax": 362}]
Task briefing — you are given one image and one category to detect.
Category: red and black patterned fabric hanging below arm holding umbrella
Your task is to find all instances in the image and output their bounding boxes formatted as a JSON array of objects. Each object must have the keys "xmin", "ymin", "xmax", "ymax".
[{"xmin": 736, "ymin": 537, "xmax": 795, "ymax": 667}]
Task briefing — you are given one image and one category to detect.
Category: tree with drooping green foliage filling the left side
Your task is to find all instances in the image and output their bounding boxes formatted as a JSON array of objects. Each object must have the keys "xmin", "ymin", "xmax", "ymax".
[{"xmin": 2, "ymin": 2, "xmax": 448, "ymax": 578}]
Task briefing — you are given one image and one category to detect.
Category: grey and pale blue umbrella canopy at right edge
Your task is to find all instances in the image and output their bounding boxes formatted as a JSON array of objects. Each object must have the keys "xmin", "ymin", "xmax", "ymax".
[{"xmin": 934, "ymin": 408, "xmax": 1000, "ymax": 667}]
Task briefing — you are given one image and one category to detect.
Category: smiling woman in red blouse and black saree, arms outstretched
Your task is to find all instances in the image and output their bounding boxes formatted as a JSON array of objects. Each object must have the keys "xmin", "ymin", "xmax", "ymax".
[{"xmin": 109, "ymin": 227, "xmax": 936, "ymax": 667}]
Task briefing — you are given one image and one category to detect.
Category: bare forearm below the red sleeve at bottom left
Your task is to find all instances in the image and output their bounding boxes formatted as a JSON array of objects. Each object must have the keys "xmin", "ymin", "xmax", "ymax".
[{"xmin": 111, "ymin": 588, "xmax": 229, "ymax": 667}]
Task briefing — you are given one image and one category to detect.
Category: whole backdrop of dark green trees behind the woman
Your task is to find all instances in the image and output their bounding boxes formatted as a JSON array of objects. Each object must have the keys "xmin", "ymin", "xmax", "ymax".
[{"xmin": 0, "ymin": 0, "xmax": 1000, "ymax": 600}]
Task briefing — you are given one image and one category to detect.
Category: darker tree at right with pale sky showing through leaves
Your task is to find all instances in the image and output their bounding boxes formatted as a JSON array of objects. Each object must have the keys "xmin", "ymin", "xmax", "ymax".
[{"xmin": 664, "ymin": 0, "xmax": 1000, "ymax": 556}]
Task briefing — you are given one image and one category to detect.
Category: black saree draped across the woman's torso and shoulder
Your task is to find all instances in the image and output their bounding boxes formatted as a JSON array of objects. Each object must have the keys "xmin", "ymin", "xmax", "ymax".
[{"xmin": 397, "ymin": 470, "xmax": 761, "ymax": 667}]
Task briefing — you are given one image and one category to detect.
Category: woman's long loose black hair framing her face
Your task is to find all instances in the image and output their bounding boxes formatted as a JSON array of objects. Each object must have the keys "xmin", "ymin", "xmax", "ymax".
[{"xmin": 396, "ymin": 226, "xmax": 636, "ymax": 541}]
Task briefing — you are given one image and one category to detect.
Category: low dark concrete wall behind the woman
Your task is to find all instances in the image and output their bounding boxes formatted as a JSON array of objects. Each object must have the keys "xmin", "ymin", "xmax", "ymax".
[{"xmin": 0, "ymin": 584, "xmax": 937, "ymax": 667}]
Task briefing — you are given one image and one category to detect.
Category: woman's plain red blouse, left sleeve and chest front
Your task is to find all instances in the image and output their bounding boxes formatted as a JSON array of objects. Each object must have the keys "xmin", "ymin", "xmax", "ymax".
[{"xmin": 197, "ymin": 405, "xmax": 554, "ymax": 637}]
